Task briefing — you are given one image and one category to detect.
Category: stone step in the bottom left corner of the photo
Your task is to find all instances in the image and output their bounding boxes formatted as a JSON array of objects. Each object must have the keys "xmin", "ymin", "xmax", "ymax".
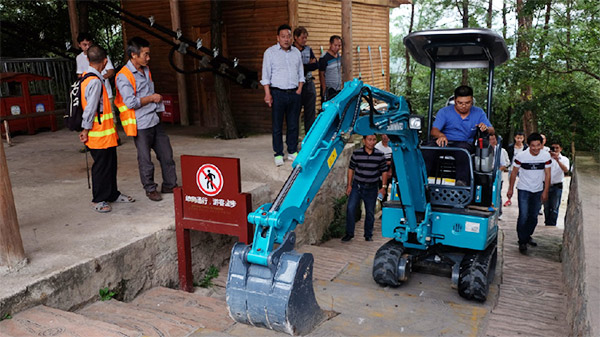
[{"xmin": 0, "ymin": 305, "xmax": 142, "ymax": 337}]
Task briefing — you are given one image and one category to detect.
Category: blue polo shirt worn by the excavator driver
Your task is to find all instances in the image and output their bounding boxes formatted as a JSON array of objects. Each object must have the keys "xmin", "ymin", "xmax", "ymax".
[{"xmin": 433, "ymin": 105, "xmax": 492, "ymax": 142}]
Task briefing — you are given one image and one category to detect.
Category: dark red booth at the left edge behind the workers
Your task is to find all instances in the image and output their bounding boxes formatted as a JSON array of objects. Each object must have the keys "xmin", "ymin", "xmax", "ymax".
[{"xmin": 0, "ymin": 73, "xmax": 57, "ymax": 134}]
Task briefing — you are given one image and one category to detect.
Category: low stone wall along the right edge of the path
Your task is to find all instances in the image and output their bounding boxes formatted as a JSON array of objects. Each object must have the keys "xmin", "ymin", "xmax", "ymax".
[{"xmin": 562, "ymin": 154, "xmax": 600, "ymax": 336}]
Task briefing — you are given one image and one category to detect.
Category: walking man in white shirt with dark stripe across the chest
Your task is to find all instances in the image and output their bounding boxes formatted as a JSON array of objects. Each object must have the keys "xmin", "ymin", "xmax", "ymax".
[{"xmin": 506, "ymin": 132, "xmax": 552, "ymax": 254}]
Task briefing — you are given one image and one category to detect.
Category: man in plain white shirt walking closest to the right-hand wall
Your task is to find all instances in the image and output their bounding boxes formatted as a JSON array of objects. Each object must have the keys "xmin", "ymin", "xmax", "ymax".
[{"xmin": 544, "ymin": 142, "xmax": 569, "ymax": 226}]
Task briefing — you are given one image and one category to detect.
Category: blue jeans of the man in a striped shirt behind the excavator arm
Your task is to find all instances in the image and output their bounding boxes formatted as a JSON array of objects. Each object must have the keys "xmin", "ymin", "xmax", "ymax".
[{"xmin": 346, "ymin": 182, "xmax": 378, "ymax": 238}]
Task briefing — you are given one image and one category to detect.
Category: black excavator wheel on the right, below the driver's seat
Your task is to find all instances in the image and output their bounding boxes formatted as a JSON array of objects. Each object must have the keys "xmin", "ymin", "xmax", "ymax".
[{"xmin": 458, "ymin": 243, "xmax": 498, "ymax": 302}]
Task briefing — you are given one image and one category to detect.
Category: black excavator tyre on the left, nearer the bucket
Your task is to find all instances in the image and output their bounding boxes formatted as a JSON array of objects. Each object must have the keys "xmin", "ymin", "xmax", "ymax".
[{"xmin": 373, "ymin": 240, "xmax": 404, "ymax": 287}]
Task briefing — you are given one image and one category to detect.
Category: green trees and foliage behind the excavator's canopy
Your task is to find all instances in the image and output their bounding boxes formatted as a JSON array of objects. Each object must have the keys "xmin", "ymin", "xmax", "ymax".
[{"xmin": 390, "ymin": 0, "xmax": 600, "ymax": 154}]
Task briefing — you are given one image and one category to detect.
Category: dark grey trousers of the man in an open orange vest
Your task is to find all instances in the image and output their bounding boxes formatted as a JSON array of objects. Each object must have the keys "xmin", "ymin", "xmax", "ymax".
[{"xmin": 133, "ymin": 124, "xmax": 177, "ymax": 192}]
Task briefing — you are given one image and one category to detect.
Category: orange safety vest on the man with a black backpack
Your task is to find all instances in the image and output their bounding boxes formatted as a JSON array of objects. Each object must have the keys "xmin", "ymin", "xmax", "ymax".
[{"xmin": 81, "ymin": 73, "xmax": 119, "ymax": 149}]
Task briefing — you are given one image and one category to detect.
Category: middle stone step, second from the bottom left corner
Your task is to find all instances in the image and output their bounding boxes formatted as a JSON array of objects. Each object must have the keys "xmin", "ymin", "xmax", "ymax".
[{"xmin": 77, "ymin": 300, "xmax": 199, "ymax": 337}]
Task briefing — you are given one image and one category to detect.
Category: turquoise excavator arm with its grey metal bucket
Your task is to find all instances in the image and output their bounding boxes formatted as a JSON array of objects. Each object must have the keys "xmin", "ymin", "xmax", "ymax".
[{"xmin": 227, "ymin": 79, "xmax": 426, "ymax": 334}]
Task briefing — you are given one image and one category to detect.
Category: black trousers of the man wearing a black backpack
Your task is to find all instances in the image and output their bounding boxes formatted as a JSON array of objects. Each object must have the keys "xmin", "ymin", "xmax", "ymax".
[{"xmin": 90, "ymin": 147, "xmax": 121, "ymax": 202}]
